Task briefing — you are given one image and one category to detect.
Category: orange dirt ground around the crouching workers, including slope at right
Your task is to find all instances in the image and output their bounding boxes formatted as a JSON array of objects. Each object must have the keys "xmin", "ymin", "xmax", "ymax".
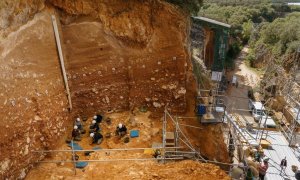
[{"xmin": 26, "ymin": 63, "xmax": 229, "ymax": 179}]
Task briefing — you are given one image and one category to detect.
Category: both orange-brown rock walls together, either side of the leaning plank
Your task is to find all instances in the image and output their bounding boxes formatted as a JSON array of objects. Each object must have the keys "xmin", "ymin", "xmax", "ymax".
[{"xmin": 0, "ymin": 0, "xmax": 191, "ymax": 179}]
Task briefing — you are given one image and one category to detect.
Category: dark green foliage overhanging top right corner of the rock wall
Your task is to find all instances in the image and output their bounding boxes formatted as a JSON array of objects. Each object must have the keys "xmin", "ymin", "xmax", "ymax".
[{"xmin": 166, "ymin": 0, "xmax": 203, "ymax": 15}]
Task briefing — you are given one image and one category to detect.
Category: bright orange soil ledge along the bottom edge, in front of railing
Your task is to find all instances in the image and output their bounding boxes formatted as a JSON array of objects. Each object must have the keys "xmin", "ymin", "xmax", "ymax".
[{"xmin": 28, "ymin": 161, "xmax": 230, "ymax": 180}]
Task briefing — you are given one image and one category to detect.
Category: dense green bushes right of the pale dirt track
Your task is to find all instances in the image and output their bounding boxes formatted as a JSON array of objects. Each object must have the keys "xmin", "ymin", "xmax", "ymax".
[{"xmin": 248, "ymin": 12, "xmax": 300, "ymax": 68}]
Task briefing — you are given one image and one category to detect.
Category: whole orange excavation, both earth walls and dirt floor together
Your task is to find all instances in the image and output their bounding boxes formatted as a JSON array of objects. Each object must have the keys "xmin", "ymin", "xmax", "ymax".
[{"xmin": 0, "ymin": 0, "xmax": 228, "ymax": 179}]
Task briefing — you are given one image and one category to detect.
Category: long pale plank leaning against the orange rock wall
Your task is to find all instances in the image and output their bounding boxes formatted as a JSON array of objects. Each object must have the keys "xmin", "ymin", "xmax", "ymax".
[{"xmin": 51, "ymin": 15, "xmax": 72, "ymax": 111}]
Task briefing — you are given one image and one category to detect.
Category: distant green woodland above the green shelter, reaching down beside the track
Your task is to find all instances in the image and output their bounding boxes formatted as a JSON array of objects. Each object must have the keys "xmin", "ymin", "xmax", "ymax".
[{"xmin": 198, "ymin": 1, "xmax": 293, "ymax": 68}]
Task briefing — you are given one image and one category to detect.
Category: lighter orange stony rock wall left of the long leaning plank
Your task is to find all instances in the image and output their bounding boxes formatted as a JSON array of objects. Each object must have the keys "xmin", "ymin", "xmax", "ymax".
[{"xmin": 0, "ymin": 10, "xmax": 68, "ymax": 179}]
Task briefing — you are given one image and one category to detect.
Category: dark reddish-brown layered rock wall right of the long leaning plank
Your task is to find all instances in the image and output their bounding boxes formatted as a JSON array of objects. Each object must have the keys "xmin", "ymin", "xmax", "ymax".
[{"xmin": 50, "ymin": 0, "xmax": 190, "ymax": 114}]
